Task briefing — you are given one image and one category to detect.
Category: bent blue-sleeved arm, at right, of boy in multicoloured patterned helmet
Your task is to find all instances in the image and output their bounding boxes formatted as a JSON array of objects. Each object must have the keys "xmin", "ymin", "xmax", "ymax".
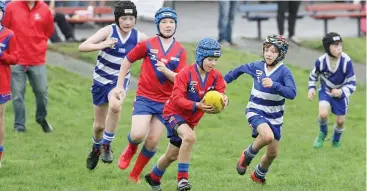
[{"xmin": 271, "ymin": 69, "xmax": 297, "ymax": 100}]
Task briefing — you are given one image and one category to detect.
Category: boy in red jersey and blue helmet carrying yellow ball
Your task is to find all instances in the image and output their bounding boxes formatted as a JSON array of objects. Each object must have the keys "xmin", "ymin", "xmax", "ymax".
[{"xmin": 145, "ymin": 38, "xmax": 228, "ymax": 191}]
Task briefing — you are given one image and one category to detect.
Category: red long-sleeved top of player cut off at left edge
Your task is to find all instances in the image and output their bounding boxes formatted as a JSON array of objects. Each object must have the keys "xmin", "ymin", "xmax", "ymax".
[{"xmin": 0, "ymin": 27, "xmax": 18, "ymax": 95}]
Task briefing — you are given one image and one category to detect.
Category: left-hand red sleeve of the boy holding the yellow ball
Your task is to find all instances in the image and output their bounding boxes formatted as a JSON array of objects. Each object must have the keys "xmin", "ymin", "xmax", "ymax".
[{"xmin": 172, "ymin": 70, "xmax": 196, "ymax": 111}]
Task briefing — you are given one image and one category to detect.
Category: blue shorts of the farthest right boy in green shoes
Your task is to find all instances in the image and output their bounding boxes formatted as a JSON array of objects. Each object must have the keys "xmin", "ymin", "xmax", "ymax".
[{"xmin": 319, "ymin": 90, "xmax": 349, "ymax": 116}]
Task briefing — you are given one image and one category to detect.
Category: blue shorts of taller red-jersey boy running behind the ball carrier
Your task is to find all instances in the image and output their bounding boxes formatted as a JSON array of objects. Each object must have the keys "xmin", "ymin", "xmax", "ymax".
[{"xmin": 133, "ymin": 96, "xmax": 165, "ymax": 124}]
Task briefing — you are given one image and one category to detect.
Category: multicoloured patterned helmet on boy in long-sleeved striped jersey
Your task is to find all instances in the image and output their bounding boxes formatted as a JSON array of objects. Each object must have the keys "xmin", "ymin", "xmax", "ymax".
[{"xmin": 263, "ymin": 34, "xmax": 288, "ymax": 65}]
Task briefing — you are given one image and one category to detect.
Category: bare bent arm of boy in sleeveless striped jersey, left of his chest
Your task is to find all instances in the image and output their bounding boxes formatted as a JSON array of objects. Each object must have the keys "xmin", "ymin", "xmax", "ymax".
[{"xmin": 79, "ymin": 25, "xmax": 116, "ymax": 52}]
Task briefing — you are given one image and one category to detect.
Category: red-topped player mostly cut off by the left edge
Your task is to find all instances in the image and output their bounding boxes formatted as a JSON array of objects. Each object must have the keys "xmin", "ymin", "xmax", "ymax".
[{"xmin": 0, "ymin": 1, "xmax": 18, "ymax": 167}]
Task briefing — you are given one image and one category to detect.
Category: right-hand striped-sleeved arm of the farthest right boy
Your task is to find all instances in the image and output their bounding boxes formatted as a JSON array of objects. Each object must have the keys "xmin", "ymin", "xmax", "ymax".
[{"xmin": 341, "ymin": 60, "xmax": 357, "ymax": 97}]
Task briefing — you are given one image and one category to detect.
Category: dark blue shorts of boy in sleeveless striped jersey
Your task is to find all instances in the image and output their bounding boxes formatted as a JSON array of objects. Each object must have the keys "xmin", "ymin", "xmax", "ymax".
[{"xmin": 91, "ymin": 78, "xmax": 130, "ymax": 105}]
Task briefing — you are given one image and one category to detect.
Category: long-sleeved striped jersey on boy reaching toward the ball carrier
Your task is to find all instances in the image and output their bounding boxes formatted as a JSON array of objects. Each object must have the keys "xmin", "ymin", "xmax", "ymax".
[{"xmin": 224, "ymin": 61, "xmax": 297, "ymax": 126}]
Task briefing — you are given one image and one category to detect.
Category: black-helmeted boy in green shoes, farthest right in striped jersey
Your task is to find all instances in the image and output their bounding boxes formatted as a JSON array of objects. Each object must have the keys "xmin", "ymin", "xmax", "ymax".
[{"xmin": 308, "ymin": 32, "xmax": 356, "ymax": 148}]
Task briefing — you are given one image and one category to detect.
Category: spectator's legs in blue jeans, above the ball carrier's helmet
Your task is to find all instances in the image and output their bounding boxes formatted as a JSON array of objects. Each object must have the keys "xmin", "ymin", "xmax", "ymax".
[{"xmin": 218, "ymin": 0, "xmax": 237, "ymax": 46}]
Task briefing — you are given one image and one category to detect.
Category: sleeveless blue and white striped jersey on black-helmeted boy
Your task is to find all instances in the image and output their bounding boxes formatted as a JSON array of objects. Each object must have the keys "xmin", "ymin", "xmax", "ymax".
[{"xmin": 93, "ymin": 24, "xmax": 139, "ymax": 85}]
